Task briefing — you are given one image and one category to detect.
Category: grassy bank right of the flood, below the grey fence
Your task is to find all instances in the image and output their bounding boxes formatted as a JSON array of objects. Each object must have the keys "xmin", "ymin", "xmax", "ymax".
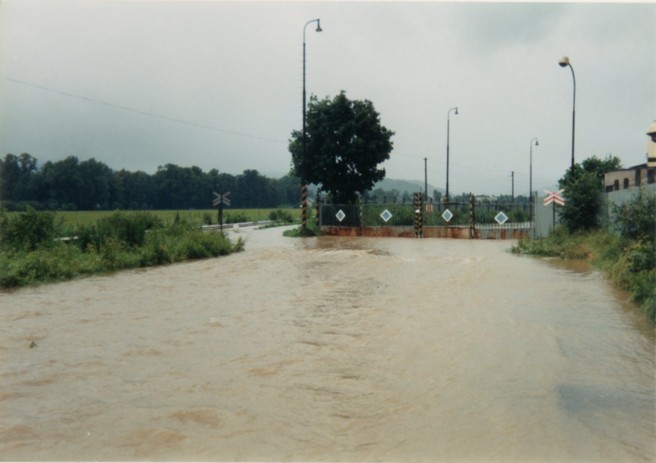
[{"xmin": 512, "ymin": 229, "xmax": 656, "ymax": 324}]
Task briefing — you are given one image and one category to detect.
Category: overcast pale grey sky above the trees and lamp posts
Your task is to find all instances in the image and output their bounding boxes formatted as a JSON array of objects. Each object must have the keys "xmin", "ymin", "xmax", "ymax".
[{"xmin": 0, "ymin": 0, "xmax": 656, "ymax": 194}]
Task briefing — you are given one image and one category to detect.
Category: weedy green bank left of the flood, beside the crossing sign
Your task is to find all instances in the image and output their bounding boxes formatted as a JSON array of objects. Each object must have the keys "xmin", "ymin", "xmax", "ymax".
[{"xmin": 0, "ymin": 210, "xmax": 251, "ymax": 288}]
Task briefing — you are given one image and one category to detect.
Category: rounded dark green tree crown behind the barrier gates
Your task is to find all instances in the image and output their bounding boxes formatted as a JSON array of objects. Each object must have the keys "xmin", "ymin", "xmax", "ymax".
[{"xmin": 289, "ymin": 91, "xmax": 394, "ymax": 203}]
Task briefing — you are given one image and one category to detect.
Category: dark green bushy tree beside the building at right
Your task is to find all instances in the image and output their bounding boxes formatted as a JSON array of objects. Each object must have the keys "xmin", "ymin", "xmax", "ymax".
[{"xmin": 559, "ymin": 155, "xmax": 622, "ymax": 232}]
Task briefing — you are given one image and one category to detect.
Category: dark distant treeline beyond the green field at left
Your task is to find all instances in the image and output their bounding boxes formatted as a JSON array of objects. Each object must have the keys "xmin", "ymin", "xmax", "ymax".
[{"xmin": 0, "ymin": 153, "xmax": 300, "ymax": 210}]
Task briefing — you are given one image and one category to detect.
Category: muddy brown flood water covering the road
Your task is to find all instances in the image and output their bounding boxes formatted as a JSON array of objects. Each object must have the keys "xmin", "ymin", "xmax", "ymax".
[{"xmin": 0, "ymin": 229, "xmax": 656, "ymax": 462}]
